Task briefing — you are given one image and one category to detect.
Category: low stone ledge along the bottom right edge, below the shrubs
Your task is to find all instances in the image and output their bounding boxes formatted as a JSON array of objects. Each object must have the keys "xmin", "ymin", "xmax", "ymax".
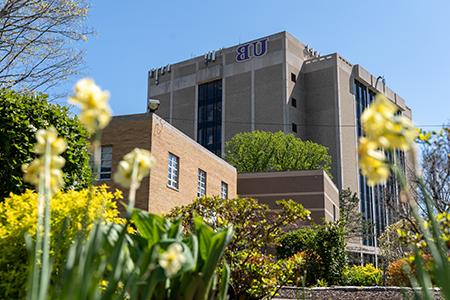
[{"xmin": 276, "ymin": 286, "xmax": 442, "ymax": 300}]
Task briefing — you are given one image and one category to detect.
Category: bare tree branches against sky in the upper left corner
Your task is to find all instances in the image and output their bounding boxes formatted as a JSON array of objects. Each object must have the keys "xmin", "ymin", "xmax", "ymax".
[{"xmin": 0, "ymin": 0, "xmax": 92, "ymax": 91}]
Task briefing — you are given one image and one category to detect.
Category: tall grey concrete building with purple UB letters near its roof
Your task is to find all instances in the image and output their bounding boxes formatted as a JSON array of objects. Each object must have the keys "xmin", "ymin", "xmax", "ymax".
[{"xmin": 148, "ymin": 32, "xmax": 411, "ymax": 262}]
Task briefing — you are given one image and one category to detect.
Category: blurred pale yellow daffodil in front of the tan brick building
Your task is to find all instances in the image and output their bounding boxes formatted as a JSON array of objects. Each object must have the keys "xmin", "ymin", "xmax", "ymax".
[{"xmin": 114, "ymin": 148, "xmax": 155, "ymax": 188}]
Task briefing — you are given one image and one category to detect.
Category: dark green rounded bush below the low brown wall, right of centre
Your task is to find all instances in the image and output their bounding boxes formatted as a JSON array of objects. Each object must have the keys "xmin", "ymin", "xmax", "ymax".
[{"xmin": 277, "ymin": 223, "xmax": 347, "ymax": 285}]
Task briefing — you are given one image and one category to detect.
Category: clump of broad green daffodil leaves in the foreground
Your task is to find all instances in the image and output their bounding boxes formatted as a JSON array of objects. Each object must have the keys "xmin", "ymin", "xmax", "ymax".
[{"xmin": 51, "ymin": 210, "xmax": 233, "ymax": 300}]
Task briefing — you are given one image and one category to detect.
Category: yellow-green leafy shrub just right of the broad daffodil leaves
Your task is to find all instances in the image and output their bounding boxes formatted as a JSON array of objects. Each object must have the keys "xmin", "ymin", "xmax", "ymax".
[{"xmin": 169, "ymin": 197, "xmax": 309, "ymax": 299}]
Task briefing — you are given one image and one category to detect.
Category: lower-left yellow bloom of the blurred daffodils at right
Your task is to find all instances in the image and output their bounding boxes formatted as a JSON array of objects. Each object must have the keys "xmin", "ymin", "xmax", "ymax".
[{"xmin": 358, "ymin": 137, "xmax": 390, "ymax": 186}]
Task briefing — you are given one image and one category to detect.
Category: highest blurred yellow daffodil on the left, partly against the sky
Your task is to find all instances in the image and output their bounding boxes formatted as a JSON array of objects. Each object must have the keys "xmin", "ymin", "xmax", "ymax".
[{"xmin": 69, "ymin": 78, "xmax": 111, "ymax": 134}]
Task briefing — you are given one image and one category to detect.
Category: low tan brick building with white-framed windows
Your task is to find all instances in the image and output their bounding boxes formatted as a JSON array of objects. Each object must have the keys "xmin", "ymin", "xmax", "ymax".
[{"xmin": 98, "ymin": 113, "xmax": 237, "ymax": 213}]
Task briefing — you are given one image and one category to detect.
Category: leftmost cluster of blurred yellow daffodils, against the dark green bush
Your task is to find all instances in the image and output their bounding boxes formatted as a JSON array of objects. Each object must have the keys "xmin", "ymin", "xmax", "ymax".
[{"xmin": 22, "ymin": 127, "xmax": 67, "ymax": 193}]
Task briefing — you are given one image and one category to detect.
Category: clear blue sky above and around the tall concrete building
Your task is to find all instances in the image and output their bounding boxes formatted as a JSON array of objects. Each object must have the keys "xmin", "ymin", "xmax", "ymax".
[{"xmin": 67, "ymin": 0, "xmax": 450, "ymax": 129}]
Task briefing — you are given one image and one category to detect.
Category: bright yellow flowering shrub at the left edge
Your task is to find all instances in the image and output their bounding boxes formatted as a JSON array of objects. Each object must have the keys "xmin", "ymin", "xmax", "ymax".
[{"xmin": 0, "ymin": 186, "xmax": 124, "ymax": 299}]
